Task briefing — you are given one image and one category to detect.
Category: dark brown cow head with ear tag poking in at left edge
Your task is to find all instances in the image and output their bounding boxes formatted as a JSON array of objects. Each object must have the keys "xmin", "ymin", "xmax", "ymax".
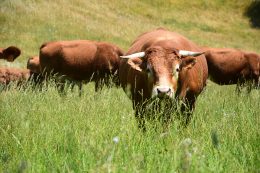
[{"xmin": 0, "ymin": 46, "xmax": 21, "ymax": 62}]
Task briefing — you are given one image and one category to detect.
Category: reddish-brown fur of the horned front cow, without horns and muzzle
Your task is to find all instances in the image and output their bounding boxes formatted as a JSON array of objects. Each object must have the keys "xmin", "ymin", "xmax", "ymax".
[{"xmin": 119, "ymin": 28, "xmax": 208, "ymax": 125}]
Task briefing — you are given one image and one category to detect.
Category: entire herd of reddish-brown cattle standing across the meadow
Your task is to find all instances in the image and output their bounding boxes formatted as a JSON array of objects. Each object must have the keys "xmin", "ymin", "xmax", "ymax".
[{"xmin": 0, "ymin": 28, "xmax": 260, "ymax": 128}]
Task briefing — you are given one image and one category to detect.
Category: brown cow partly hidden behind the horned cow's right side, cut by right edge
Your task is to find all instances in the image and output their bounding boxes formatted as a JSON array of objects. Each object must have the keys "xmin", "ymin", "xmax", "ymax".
[{"xmin": 202, "ymin": 47, "xmax": 260, "ymax": 92}]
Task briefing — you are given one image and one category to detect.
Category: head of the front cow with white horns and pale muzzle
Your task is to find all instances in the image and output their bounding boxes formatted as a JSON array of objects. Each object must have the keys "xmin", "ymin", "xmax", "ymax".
[{"xmin": 121, "ymin": 46, "xmax": 203, "ymax": 98}]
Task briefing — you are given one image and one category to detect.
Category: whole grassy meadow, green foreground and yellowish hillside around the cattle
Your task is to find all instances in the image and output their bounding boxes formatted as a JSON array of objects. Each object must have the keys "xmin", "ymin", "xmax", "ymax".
[{"xmin": 0, "ymin": 0, "xmax": 260, "ymax": 173}]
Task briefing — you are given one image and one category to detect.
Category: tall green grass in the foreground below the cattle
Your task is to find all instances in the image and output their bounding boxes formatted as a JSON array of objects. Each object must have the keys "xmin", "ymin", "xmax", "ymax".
[{"xmin": 0, "ymin": 83, "xmax": 260, "ymax": 172}]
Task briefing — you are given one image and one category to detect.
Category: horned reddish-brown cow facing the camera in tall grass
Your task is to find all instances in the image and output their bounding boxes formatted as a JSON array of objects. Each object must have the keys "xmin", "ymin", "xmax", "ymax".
[{"xmin": 119, "ymin": 28, "xmax": 208, "ymax": 128}]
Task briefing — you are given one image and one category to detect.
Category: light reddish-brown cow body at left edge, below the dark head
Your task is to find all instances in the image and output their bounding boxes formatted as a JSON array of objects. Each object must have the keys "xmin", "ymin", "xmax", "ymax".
[{"xmin": 0, "ymin": 67, "xmax": 30, "ymax": 87}]
